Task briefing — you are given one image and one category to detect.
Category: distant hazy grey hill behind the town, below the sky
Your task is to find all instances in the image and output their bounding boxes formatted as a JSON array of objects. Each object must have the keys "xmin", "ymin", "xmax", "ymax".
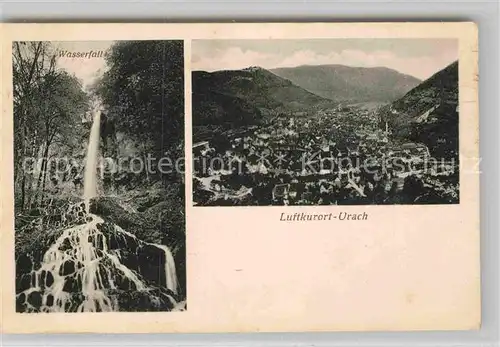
[{"xmin": 271, "ymin": 65, "xmax": 420, "ymax": 103}]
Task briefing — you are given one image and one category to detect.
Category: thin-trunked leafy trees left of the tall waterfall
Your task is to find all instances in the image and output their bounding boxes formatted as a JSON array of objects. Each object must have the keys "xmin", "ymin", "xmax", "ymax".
[{"xmin": 13, "ymin": 42, "xmax": 88, "ymax": 210}]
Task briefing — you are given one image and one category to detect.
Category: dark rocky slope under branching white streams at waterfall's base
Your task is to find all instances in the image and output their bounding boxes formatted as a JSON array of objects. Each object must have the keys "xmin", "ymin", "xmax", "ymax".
[{"xmin": 16, "ymin": 198, "xmax": 184, "ymax": 312}]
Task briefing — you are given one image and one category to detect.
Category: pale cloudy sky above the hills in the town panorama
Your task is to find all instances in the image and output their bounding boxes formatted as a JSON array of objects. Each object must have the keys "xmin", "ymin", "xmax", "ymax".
[{"xmin": 191, "ymin": 39, "xmax": 458, "ymax": 80}]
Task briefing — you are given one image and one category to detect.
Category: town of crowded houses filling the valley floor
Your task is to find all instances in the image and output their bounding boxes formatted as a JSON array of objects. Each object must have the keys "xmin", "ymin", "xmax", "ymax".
[{"xmin": 193, "ymin": 106, "xmax": 458, "ymax": 206}]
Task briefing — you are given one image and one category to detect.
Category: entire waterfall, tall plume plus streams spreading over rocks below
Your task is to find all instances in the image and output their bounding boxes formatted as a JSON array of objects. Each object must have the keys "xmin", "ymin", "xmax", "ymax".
[{"xmin": 16, "ymin": 113, "xmax": 183, "ymax": 312}]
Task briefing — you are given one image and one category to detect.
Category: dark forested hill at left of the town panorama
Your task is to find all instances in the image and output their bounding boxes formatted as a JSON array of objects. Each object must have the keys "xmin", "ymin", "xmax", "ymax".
[{"xmin": 192, "ymin": 67, "xmax": 334, "ymax": 125}]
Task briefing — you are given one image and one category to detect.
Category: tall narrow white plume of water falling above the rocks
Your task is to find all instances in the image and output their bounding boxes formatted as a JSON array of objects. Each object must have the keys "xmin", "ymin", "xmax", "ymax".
[{"xmin": 83, "ymin": 111, "xmax": 101, "ymax": 212}]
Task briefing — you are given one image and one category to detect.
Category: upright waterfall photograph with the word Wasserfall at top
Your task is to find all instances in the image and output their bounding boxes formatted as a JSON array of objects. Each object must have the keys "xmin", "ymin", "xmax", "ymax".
[{"xmin": 12, "ymin": 40, "xmax": 187, "ymax": 313}]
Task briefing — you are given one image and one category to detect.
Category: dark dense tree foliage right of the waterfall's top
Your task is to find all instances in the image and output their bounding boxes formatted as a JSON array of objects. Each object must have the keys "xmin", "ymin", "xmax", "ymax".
[{"xmin": 93, "ymin": 41, "xmax": 184, "ymax": 185}]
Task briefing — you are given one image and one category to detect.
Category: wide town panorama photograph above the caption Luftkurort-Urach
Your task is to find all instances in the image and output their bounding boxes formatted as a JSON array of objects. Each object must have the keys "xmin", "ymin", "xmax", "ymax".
[{"xmin": 191, "ymin": 38, "xmax": 460, "ymax": 206}]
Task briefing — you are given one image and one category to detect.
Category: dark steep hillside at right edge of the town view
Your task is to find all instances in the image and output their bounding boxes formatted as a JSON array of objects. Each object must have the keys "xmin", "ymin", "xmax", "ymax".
[{"xmin": 380, "ymin": 61, "xmax": 458, "ymax": 158}]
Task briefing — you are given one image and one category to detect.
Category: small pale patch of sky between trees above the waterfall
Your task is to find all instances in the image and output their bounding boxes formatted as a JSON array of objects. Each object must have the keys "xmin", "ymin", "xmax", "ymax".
[{"xmin": 53, "ymin": 41, "xmax": 113, "ymax": 87}]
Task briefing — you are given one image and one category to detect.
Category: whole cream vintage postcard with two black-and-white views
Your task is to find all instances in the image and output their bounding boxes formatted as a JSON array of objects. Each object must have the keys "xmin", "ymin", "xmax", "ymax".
[{"xmin": 0, "ymin": 22, "xmax": 481, "ymax": 333}]
